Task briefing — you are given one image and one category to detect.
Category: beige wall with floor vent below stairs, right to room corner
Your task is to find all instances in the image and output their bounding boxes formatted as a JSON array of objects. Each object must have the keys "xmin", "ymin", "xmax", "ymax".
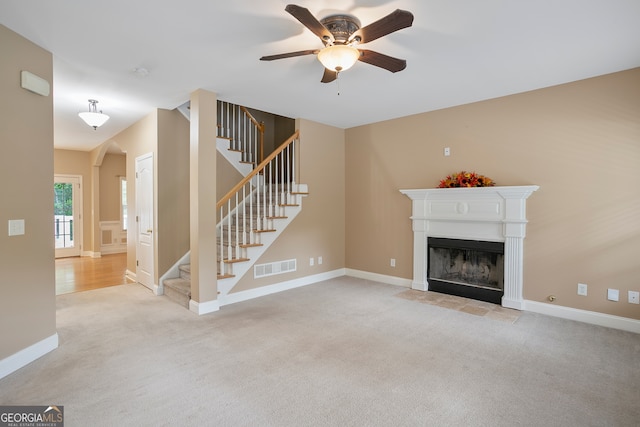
[{"xmin": 232, "ymin": 120, "xmax": 345, "ymax": 292}]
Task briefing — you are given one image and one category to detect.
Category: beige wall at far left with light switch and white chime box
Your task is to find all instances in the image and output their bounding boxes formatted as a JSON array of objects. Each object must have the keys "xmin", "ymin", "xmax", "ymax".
[{"xmin": 0, "ymin": 25, "xmax": 56, "ymax": 361}]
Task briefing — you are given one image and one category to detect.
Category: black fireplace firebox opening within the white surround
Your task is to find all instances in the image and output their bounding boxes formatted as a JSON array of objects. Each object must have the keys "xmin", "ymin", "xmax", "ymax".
[{"xmin": 427, "ymin": 237, "xmax": 504, "ymax": 304}]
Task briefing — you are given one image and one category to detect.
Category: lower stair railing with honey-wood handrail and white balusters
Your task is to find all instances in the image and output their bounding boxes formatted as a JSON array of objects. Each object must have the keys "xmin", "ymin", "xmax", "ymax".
[{"xmin": 216, "ymin": 131, "xmax": 300, "ymax": 278}]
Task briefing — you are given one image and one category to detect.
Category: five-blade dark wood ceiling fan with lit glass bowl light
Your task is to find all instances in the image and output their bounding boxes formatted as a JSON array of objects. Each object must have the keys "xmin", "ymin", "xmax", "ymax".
[{"xmin": 260, "ymin": 4, "xmax": 413, "ymax": 83}]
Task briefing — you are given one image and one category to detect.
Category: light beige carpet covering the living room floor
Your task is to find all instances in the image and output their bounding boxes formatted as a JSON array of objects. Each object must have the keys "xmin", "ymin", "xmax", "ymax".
[{"xmin": 0, "ymin": 277, "xmax": 640, "ymax": 427}]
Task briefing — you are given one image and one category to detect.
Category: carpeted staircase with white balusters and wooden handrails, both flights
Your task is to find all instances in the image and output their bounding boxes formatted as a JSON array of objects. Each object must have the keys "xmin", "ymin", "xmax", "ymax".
[{"xmin": 162, "ymin": 104, "xmax": 308, "ymax": 308}]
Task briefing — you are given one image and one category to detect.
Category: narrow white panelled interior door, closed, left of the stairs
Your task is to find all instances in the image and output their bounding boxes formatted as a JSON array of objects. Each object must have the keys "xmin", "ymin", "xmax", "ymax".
[{"xmin": 135, "ymin": 153, "xmax": 155, "ymax": 291}]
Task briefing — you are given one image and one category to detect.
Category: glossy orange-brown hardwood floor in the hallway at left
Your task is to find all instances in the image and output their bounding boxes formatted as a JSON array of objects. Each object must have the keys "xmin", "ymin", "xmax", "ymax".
[{"xmin": 56, "ymin": 253, "xmax": 132, "ymax": 295}]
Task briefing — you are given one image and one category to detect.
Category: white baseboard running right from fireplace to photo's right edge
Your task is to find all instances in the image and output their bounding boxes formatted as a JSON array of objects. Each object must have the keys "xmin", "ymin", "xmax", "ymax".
[{"xmin": 524, "ymin": 300, "xmax": 640, "ymax": 334}]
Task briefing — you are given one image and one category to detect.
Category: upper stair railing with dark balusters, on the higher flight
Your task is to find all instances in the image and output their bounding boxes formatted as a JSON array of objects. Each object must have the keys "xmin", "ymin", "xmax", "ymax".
[{"xmin": 217, "ymin": 101, "xmax": 264, "ymax": 165}]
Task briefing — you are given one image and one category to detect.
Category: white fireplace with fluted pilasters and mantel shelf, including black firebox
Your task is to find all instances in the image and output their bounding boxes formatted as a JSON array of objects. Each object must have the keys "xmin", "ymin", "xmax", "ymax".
[{"xmin": 400, "ymin": 185, "xmax": 539, "ymax": 310}]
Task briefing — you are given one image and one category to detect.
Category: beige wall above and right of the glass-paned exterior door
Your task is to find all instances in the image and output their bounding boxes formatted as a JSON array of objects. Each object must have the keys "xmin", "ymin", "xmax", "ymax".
[{"xmin": 53, "ymin": 149, "xmax": 93, "ymax": 251}]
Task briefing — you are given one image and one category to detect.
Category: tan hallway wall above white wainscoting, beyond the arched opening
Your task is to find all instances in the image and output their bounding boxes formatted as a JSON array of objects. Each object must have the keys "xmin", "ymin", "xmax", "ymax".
[{"xmin": 100, "ymin": 153, "xmax": 127, "ymax": 221}]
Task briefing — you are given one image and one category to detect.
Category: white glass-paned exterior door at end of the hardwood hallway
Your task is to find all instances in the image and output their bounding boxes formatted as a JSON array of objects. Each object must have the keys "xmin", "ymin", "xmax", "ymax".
[{"xmin": 53, "ymin": 175, "xmax": 82, "ymax": 258}]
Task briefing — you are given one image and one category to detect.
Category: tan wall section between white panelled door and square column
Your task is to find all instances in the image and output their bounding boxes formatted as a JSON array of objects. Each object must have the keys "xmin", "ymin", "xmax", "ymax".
[{"xmin": 156, "ymin": 110, "xmax": 190, "ymax": 276}]
